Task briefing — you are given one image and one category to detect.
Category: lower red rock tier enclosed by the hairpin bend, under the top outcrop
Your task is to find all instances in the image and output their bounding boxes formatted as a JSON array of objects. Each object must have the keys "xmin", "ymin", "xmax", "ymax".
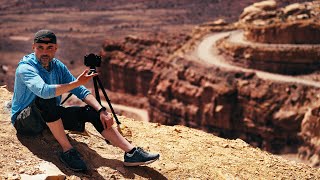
[{"xmin": 216, "ymin": 31, "xmax": 320, "ymax": 75}]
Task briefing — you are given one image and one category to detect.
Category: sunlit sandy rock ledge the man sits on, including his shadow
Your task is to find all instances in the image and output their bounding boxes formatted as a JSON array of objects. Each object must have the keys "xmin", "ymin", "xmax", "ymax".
[{"xmin": 0, "ymin": 88, "xmax": 320, "ymax": 179}]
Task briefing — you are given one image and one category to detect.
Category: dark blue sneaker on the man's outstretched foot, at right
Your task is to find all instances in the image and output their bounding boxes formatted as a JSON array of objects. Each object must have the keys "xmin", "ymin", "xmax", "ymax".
[{"xmin": 123, "ymin": 147, "xmax": 160, "ymax": 166}]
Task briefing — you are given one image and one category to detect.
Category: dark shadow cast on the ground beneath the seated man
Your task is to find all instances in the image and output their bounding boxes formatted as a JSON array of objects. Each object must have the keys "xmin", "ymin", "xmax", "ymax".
[{"xmin": 17, "ymin": 130, "xmax": 167, "ymax": 179}]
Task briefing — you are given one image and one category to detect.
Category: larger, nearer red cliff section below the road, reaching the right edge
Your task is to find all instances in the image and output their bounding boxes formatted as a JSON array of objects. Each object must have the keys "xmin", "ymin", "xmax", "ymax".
[{"xmin": 148, "ymin": 58, "xmax": 320, "ymax": 153}]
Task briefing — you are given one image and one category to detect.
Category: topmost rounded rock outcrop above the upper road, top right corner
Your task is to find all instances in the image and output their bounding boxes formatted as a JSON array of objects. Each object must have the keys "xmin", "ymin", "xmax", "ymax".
[{"xmin": 239, "ymin": 0, "xmax": 320, "ymax": 44}]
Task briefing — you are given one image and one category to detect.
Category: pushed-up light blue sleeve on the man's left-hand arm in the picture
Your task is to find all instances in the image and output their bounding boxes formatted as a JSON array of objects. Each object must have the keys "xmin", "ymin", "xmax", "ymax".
[{"xmin": 16, "ymin": 64, "xmax": 56, "ymax": 99}]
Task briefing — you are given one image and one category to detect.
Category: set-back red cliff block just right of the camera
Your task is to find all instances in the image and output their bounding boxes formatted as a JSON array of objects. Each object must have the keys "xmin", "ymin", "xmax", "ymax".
[{"xmin": 101, "ymin": 35, "xmax": 190, "ymax": 96}]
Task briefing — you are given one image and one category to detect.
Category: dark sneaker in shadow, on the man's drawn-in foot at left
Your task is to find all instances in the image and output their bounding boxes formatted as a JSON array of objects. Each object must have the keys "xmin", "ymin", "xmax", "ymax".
[{"xmin": 60, "ymin": 148, "xmax": 87, "ymax": 171}]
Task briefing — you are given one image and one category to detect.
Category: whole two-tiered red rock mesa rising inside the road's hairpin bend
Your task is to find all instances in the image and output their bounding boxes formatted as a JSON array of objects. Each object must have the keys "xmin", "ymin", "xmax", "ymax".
[{"xmin": 217, "ymin": 0, "xmax": 320, "ymax": 75}]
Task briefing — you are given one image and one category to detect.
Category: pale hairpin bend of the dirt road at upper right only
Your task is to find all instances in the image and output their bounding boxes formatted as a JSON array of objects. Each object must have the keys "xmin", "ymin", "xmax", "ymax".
[{"xmin": 196, "ymin": 30, "xmax": 320, "ymax": 88}]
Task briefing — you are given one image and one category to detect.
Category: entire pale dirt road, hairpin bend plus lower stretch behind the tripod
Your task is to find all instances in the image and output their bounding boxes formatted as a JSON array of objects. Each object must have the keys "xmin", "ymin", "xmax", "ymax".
[{"xmin": 99, "ymin": 30, "xmax": 320, "ymax": 121}]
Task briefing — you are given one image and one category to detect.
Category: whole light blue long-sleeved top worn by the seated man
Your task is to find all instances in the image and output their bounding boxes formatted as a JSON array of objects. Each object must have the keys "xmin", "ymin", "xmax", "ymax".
[{"xmin": 11, "ymin": 53, "xmax": 90, "ymax": 124}]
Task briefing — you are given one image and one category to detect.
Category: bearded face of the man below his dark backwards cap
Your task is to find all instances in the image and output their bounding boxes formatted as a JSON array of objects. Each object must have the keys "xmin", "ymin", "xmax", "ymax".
[{"xmin": 32, "ymin": 43, "xmax": 58, "ymax": 67}]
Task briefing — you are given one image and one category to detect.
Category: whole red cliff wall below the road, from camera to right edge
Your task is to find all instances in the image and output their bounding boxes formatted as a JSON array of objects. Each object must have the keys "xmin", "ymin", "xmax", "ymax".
[{"xmin": 101, "ymin": 32, "xmax": 320, "ymax": 155}]
